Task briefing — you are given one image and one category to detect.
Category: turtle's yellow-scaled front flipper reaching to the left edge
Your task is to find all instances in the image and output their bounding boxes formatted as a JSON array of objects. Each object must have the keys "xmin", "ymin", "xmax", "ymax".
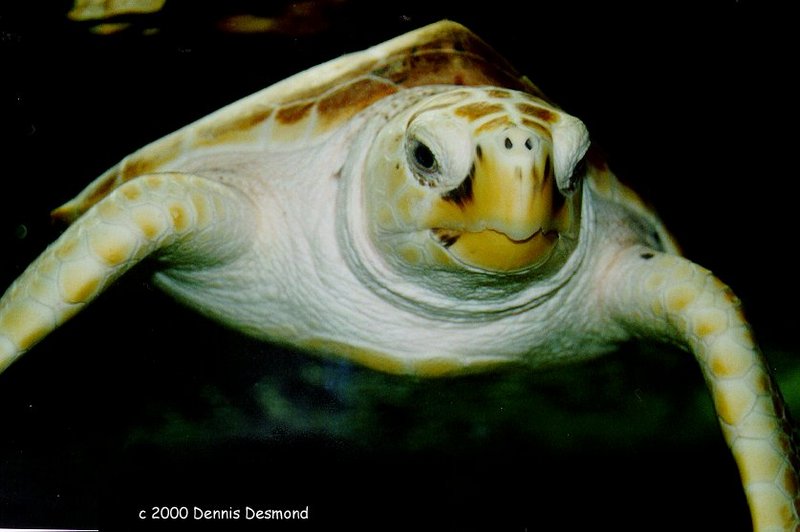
[{"xmin": 0, "ymin": 173, "xmax": 256, "ymax": 371}]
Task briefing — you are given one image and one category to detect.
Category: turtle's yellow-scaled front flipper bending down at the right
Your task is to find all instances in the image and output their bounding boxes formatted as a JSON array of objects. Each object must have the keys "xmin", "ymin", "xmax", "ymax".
[{"xmin": 603, "ymin": 247, "xmax": 800, "ymax": 530}]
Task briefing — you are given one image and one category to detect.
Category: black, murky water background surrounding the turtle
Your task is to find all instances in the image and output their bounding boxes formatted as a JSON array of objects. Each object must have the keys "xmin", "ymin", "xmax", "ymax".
[{"xmin": 0, "ymin": 0, "xmax": 800, "ymax": 531}]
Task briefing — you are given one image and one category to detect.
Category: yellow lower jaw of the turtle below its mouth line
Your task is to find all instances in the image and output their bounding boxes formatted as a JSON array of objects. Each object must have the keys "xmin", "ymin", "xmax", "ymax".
[{"xmin": 431, "ymin": 228, "xmax": 559, "ymax": 272}]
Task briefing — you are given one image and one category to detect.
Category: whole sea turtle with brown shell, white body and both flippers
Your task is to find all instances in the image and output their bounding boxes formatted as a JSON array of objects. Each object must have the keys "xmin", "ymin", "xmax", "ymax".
[{"xmin": 0, "ymin": 21, "xmax": 800, "ymax": 530}]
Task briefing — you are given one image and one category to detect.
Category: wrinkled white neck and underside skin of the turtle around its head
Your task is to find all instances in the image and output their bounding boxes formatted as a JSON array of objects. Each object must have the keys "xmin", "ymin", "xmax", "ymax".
[{"xmin": 145, "ymin": 92, "xmax": 644, "ymax": 372}]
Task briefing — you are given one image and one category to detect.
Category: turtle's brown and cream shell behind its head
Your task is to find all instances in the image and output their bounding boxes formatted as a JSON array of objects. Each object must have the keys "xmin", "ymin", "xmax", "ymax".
[{"xmin": 53, "ymin": 20, "xmax": 544, "ymax": 222}]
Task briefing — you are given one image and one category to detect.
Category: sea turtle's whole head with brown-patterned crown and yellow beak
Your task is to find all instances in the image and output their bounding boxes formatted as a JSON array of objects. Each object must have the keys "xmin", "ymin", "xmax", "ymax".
[{"xmin": 365, "ymin": 88, "xmax": 589, "ymax": 282}]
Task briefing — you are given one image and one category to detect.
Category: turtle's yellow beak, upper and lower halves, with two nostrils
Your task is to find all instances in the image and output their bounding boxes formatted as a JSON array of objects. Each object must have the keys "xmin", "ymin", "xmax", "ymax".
[{"xmin": 428, "ymin": 128, "xmax": 574, "ymax": 272}]
